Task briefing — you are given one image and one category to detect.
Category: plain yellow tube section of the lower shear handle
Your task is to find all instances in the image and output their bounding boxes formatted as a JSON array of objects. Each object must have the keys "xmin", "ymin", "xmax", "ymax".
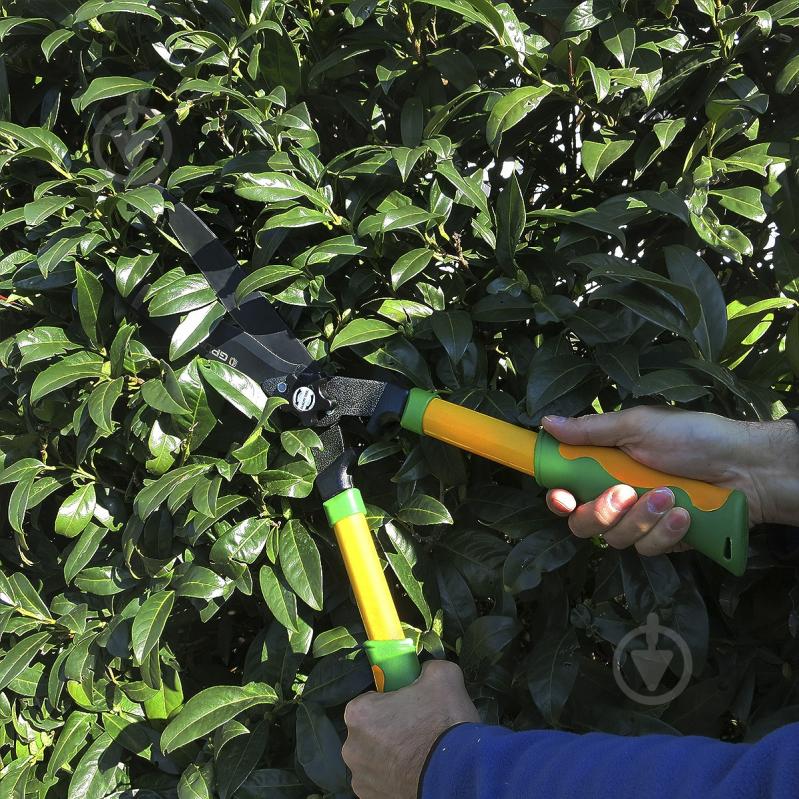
[{"xmin": 333, "ymin": 513, "xmax": 405, "ymax": 641}]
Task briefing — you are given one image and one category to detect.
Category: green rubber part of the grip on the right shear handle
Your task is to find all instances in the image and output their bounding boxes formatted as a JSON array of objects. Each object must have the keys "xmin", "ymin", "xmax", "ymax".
[{"xmin": 534, "ymin": 430, "xmax": 749, "ymax": 575}]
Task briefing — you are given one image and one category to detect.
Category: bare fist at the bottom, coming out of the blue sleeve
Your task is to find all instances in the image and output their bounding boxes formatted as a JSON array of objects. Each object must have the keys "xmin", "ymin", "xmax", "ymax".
[{"xmin": 341, "ymin": 660, "xmax": 480, "ymax": 799}]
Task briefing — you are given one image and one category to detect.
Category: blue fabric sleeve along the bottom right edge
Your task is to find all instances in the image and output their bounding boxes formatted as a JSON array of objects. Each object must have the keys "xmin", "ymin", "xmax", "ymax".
[{"xmin": 419, "ymin": 724, "xmax": 799, "ymax": 799}]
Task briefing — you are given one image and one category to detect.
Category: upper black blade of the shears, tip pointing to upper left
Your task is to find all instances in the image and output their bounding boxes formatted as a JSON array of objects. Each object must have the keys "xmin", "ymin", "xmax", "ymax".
[{"xmin": 169, "ymin": 202, "xmax": 313, "ymax": 382}]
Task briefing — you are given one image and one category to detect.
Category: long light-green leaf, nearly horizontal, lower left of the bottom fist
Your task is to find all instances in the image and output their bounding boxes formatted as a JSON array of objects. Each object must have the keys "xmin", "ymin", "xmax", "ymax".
[{"xmin": 161, "ymin": 683, "xmax": 277, "ymax": 752}]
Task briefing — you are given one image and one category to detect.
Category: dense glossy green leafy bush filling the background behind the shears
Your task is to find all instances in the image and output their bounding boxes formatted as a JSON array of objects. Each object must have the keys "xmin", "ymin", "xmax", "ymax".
[{"xmin": 0, "ymin": 0, "xmax": 799, "ymax": 799}]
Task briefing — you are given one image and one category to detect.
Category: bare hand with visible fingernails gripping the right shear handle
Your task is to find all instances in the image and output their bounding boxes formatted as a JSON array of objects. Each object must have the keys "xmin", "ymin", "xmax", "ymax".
[{"xmin": 543, "ymin": 406, "xmax": 799, "ymax": 555}]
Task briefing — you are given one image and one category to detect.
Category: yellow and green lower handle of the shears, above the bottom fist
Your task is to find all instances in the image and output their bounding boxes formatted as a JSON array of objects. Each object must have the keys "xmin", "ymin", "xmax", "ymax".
[{"xmin": 324, "ymin": 488, "xmax": 421, "ymax": 691}]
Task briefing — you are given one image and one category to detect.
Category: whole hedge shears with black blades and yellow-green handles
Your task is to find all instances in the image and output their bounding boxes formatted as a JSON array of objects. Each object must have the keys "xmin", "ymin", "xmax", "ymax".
[{"xmin": 139, "ymin": 198, "xmax": 748, "ymax": 691}]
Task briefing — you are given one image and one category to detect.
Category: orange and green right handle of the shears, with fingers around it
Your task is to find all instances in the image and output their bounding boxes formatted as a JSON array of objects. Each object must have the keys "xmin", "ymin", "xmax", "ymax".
[{"xmin": 401, "ymin": 389, "xmax": 749, "ymax": 575}]
